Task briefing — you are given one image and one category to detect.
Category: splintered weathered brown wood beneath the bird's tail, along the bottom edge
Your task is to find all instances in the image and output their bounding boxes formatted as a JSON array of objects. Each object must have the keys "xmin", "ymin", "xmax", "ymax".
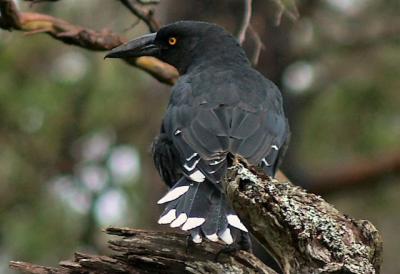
[{"xmin": 10, "ymin": 228, "xmax": 276, "ymax": 274}]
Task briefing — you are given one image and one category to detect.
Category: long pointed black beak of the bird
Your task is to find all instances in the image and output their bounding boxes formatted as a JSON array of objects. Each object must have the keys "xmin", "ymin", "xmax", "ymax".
[{"xmin": 104, "ymin": 33, "xmax": 160, "ymax": 59}]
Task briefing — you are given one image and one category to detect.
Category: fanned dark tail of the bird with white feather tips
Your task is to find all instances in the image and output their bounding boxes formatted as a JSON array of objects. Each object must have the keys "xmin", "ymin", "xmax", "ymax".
[{"xmin": 158, "ymin": 177, "xmax": 247, "ymax": 244}]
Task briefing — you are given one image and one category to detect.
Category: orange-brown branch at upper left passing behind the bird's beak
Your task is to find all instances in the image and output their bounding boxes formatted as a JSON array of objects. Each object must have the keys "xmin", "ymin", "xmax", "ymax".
[{"xmin": 0, "ymin": 0, "xmax": 179, "ymax": 85}]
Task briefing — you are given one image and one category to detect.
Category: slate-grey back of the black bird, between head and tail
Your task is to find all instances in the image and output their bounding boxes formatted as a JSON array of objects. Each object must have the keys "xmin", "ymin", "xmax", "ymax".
[{"xmin": 164, "ymin": 66, "xmax": 288, "ymax": 175}]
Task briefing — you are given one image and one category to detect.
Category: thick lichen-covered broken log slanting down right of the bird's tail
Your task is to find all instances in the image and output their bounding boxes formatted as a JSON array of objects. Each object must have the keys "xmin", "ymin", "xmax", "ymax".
[{"xmin": 225, "ymin": 163, "xmax": 382, "ymax": 274}]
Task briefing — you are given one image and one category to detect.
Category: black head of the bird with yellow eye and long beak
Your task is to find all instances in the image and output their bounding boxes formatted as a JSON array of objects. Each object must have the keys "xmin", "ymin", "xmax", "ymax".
[{"xmin": 105, "ymin": 21, "xmax": 247, "ymax": 74}]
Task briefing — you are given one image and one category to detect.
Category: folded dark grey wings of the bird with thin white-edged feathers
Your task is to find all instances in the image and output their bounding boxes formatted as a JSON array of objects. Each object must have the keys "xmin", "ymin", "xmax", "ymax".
[{"xmin": 164, "ymin": 77, "xmax": 288, "ymax": 182}]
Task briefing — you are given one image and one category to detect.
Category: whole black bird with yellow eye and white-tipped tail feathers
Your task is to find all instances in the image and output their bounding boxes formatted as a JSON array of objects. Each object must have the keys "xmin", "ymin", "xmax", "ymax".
[{"xmin": 106, "ymin": 21, "xmax": 289, "ymax": 244}]
